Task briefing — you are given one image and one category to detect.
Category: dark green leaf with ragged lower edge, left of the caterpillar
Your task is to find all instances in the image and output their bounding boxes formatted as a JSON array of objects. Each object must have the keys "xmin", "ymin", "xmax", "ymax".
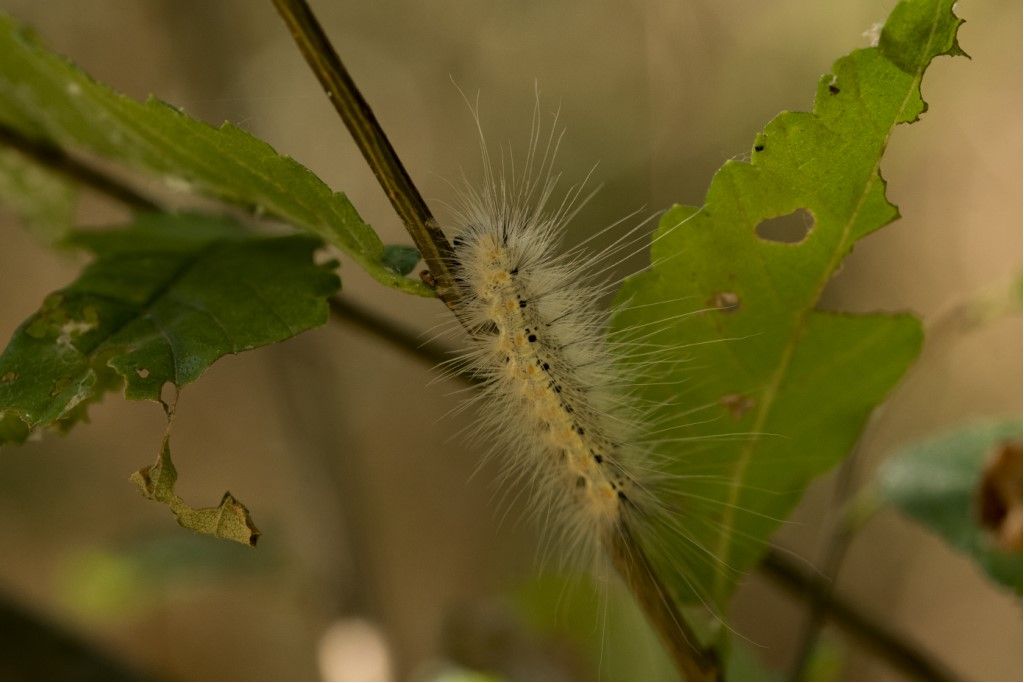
[{"xmin": 0, "ymin": 214, "xmax": 340, "ymax": 443}]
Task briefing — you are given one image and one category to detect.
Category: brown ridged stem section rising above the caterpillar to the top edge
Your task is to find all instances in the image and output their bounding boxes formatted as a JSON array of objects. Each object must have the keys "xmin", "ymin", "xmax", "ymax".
[{"xmin": 273, "ymin": 0, "xmax": 458, "ymax": 308}]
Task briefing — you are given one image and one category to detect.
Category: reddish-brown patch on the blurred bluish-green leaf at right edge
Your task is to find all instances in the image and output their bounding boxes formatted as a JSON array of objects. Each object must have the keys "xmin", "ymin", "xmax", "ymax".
[{"xmin": 977, "ymin": 441, "xmax": 1024, "ymax": 553}]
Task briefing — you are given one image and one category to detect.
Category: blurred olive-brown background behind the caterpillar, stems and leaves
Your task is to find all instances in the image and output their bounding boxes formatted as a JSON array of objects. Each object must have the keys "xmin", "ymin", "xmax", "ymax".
[{"xmin": 0, "ymin": 0, "xmax": 1022, "ymax": 680}]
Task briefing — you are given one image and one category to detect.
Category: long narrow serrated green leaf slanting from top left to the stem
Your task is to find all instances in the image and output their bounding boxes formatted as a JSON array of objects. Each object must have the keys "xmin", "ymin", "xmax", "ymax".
[{"xmin": 0, "ymin": 14, "xmax": 434, "ymax": 296}]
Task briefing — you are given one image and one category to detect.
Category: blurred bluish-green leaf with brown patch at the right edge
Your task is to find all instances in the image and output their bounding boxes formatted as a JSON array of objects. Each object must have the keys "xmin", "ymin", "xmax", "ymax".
[{"xmin": 878, "ymin": 420, "xmax": 1021, "ymax": 595}]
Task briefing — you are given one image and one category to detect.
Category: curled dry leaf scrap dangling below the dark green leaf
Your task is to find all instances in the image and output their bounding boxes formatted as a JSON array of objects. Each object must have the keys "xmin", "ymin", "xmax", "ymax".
[{"xmin": 131, "ymin": 434, "xmax": 260, "ymax": 547}]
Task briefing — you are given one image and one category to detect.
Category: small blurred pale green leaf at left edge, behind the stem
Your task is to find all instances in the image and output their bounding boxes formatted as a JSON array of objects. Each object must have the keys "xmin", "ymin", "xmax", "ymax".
[{"xmin": 0, "ymin": 147, "xmax": 78, "ymax": 244}]
